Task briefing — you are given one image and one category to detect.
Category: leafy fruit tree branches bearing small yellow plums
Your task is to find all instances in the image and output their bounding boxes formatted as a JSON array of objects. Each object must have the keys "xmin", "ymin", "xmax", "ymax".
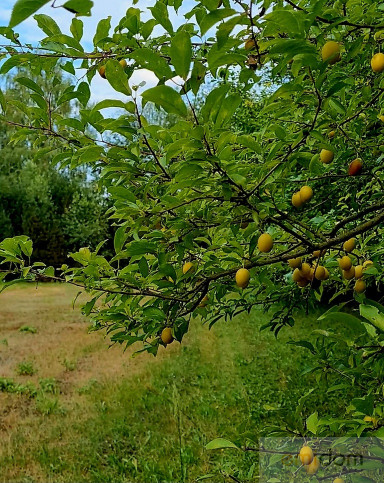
[{"xmin": 0, "ymin": 0, "xmax": 384, "ymax": 480}]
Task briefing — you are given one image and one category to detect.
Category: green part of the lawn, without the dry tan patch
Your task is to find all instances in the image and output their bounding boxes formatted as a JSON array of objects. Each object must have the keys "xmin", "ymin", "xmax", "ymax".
[{"xmin": 0, "ymin": 288, "xmax": 356, "ymax": 483}]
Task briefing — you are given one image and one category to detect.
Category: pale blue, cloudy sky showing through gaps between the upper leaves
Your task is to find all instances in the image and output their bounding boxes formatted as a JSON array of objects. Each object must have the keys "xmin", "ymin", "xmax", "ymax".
[{"xmin": 0, "ymin": 0, "xmax": 193, "ymax": 102}]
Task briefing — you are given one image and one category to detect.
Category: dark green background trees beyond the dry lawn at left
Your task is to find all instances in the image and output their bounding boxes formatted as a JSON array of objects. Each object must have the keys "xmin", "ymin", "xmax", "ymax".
[{"xmin": 0, "ymin": 75, "xmax": 113, "ymax": 267}]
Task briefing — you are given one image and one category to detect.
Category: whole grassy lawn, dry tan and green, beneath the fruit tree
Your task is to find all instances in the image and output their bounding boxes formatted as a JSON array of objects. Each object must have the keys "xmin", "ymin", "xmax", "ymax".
[{"xmin": 0, "ymin": 286, "xmax": 356, "ymax": 483}]
